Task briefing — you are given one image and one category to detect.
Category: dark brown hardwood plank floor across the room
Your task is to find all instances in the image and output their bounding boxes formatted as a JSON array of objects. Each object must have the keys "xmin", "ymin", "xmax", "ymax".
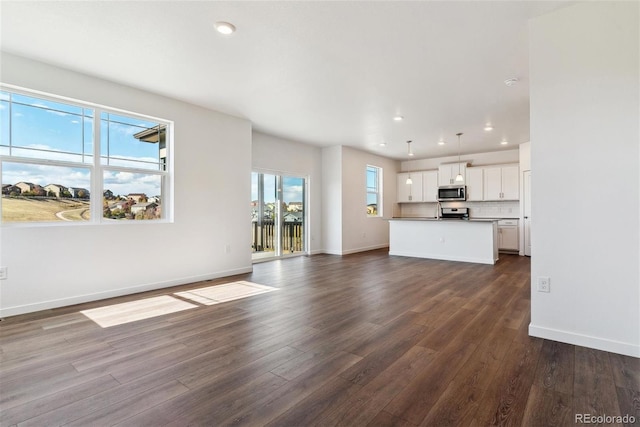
[{"xmin": 0, "ymin": 250, "xmax": 640, "ymax": 427}]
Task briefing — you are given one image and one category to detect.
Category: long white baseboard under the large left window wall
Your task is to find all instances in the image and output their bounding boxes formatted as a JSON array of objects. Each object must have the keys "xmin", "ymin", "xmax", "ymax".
[{"xmin": 0, "ymin": 266, "xmax": 253, "ymax": 318}]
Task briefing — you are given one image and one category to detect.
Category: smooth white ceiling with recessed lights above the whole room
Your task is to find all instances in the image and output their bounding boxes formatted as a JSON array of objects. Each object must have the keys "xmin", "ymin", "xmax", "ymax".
[{"xmin": 0, "ymin": 1, "xmax": 570, "ymax": 159}]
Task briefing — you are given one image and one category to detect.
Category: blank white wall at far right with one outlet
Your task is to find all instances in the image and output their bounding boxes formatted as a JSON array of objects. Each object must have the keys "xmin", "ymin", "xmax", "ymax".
[{"xmin": 529, "ymin": 2, "xmax": 640, "ymax": 357}]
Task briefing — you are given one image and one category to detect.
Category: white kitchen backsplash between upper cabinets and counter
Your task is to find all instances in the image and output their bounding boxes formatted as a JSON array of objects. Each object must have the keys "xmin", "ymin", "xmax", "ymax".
[{"xmin": 393, "ymin": 201, "xmax": 520, "ymax": 218}]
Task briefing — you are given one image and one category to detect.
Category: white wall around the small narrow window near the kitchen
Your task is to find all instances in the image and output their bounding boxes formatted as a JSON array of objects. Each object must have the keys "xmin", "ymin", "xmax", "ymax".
[{"xmin": 342, "ymin": 147, "xmax": 398, "ymax": 254}]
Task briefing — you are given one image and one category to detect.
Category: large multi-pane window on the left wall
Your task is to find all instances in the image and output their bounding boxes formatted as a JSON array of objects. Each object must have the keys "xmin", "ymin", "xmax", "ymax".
[{"xmin": 0, "ymin": 90, "xmax": 170, "ymax": 224}]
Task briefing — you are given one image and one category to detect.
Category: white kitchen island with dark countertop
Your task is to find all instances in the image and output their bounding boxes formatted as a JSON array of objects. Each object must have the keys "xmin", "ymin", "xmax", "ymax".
[{"xmin": 389, "ymin": 218, "xmax": 498, "ymax": 264}]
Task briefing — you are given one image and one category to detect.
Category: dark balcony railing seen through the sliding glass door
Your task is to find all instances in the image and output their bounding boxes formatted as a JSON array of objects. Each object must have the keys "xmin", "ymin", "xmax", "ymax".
[{"xmin": 251, "ymin": 219, "xmax": 304, "ymax": 253}]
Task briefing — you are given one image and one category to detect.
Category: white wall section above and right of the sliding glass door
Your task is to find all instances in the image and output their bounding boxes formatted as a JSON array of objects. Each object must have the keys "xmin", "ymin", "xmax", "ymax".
[{"xmin": 251, "ymin": 131, "xmax": 322, "ymax": 254}]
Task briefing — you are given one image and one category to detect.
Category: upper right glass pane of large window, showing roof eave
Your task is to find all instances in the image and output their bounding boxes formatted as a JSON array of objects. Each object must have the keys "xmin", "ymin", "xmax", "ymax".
[{"xmin": 100, "ymin": 113, "xmax": 167, "ymax": 170}]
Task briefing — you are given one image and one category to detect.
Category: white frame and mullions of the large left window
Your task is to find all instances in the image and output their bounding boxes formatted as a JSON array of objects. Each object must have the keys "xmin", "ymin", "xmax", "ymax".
[{"xmin": 0, "ymin": 83, "xmax": 174, "ymax": 228}]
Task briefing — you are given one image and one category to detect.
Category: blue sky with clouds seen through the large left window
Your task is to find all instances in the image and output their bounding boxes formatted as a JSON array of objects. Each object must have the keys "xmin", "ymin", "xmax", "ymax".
[{"xmin": 0, "ymin": 92, "xmax": 165, "ymax": 196}]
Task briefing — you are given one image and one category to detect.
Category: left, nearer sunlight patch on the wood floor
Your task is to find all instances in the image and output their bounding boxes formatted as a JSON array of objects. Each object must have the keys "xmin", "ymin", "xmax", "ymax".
[{"xmin": 80, "ymin": 295, "xmax": 198, "ymax": 328}]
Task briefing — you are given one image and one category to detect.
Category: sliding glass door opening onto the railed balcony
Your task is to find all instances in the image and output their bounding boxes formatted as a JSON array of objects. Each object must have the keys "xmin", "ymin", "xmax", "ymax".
[{"xmin": 251, "ymin": 172, "xmax": 307, "ymax": 261}]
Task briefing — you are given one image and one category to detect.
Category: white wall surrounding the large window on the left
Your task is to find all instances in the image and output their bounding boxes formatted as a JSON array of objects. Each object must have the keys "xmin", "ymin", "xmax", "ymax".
[{"xmin": 0, "ymin": 54, "xmax": 251, "ymax": 316}]
